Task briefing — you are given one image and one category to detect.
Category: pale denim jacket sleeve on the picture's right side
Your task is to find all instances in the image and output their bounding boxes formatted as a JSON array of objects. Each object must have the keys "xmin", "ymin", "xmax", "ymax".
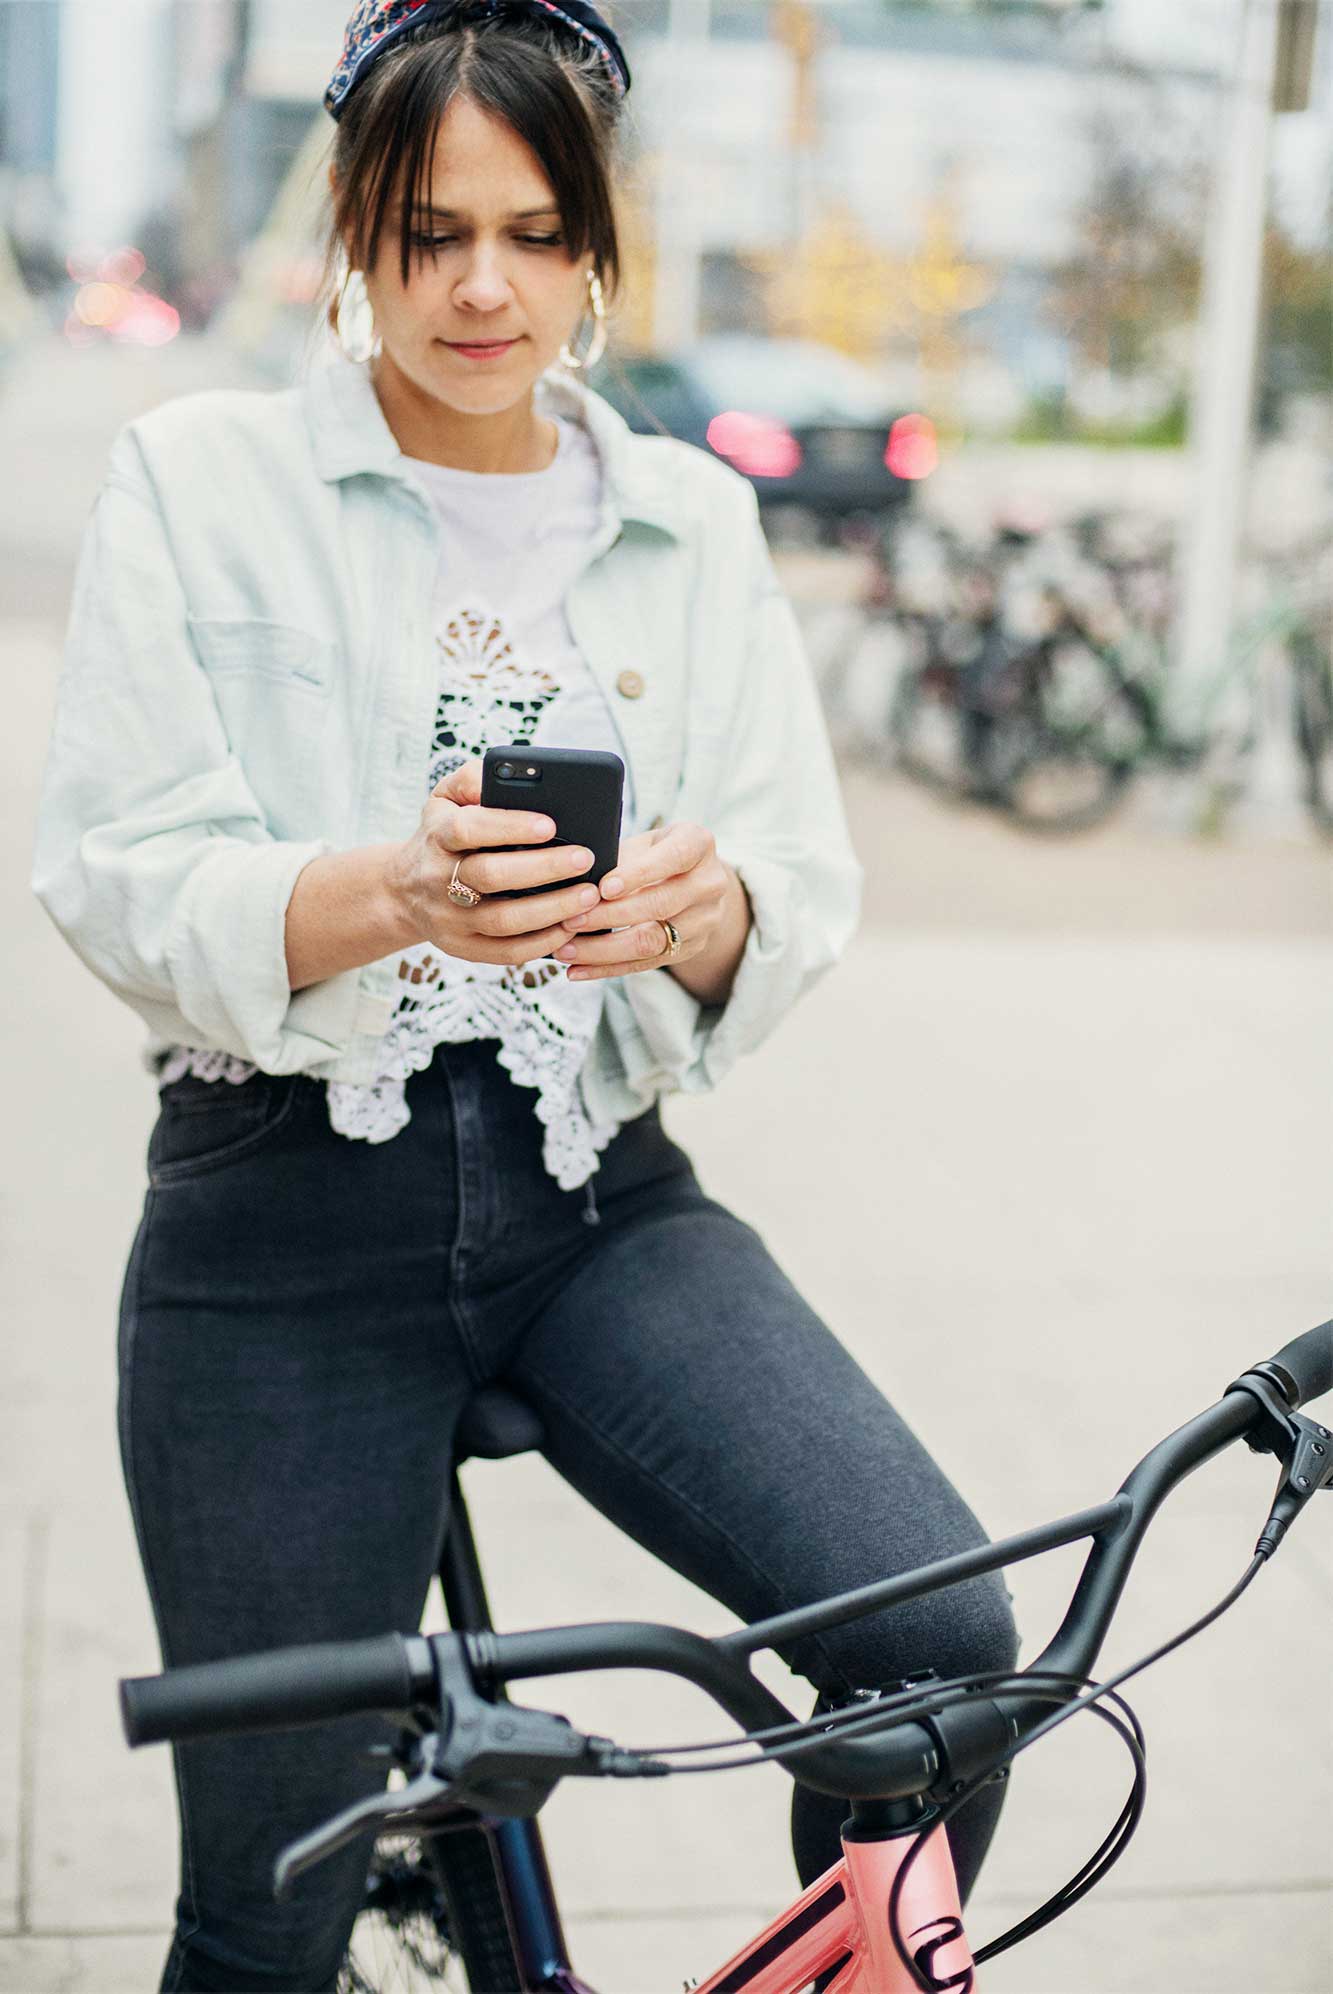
[{"xmin": 593, "ymin": 479, "xmax": 863, "ymax": 1093}]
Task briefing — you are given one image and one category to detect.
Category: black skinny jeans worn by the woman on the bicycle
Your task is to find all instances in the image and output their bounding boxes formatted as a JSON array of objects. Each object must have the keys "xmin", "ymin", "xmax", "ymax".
[{"xmin": 120, "ymin": 1045, "xmax": 1014, "ymax": 1994}]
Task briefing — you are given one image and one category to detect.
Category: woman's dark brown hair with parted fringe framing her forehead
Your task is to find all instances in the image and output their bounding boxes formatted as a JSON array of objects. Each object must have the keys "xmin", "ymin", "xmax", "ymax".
[{"xmin": 321, "ymin": 14, "xmax": 622, "ymax": 329}]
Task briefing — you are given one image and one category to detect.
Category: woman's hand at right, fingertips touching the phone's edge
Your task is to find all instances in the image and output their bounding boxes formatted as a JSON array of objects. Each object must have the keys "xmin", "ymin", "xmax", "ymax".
[{"xmin": 552, "ymin": 824, "xmax": 749, "ymax": 1005}]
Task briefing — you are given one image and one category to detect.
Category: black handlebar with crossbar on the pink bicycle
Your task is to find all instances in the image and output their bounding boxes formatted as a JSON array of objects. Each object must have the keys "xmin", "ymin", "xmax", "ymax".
[{"xmin": 120, "ymin": 1322, "xmax": 1333, "ymax": 1799}]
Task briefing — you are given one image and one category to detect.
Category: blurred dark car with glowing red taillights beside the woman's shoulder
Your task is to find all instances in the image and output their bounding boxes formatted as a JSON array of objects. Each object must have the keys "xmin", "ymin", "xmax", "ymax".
[{"xmin": 590, "ymin": 333, "xmax": 938, "ymax": 520}]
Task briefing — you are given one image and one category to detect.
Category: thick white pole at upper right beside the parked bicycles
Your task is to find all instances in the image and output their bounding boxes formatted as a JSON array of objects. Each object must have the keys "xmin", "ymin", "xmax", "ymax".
[{"xmin": 1174, "ymin": 0, "xmax": 1277, "ymax": 728}]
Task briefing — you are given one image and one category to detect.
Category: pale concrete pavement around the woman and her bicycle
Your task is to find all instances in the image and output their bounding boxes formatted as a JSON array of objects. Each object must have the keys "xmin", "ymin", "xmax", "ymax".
[{"xmin": 0, "ymin": 337, "xmax": 1333, "ymax": 1994}]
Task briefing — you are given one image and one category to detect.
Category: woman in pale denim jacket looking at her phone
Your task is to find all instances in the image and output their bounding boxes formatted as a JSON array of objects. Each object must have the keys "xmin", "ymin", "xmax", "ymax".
[{"xmin": 34, "ymin": 0, "xmax": 1012, "ymax": 1990}]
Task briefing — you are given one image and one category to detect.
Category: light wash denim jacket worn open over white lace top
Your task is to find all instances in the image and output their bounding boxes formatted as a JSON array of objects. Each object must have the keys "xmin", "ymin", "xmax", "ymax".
[{"xmin": 32, "ymin": 359, "xmax": 861, "ymax": 1123}]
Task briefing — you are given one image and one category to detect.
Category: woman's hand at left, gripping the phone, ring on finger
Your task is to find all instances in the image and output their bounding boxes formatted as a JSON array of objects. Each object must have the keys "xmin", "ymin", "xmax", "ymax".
[{"xmin": 387, "ymin": 762, "xmax": 597, "ymax": 963}]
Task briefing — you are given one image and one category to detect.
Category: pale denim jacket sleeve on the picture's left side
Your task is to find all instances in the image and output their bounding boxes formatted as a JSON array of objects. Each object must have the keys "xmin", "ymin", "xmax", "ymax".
[{"xmin": 32, "ymin": 425, "xmax": 357, "ymax": 1073}]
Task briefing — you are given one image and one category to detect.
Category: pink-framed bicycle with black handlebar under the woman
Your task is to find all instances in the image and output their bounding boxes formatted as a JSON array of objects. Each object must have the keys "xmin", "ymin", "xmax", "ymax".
[{"xmin": 120, "ymin": 1320, "xmax": 1333, "ymax": 1994}]
